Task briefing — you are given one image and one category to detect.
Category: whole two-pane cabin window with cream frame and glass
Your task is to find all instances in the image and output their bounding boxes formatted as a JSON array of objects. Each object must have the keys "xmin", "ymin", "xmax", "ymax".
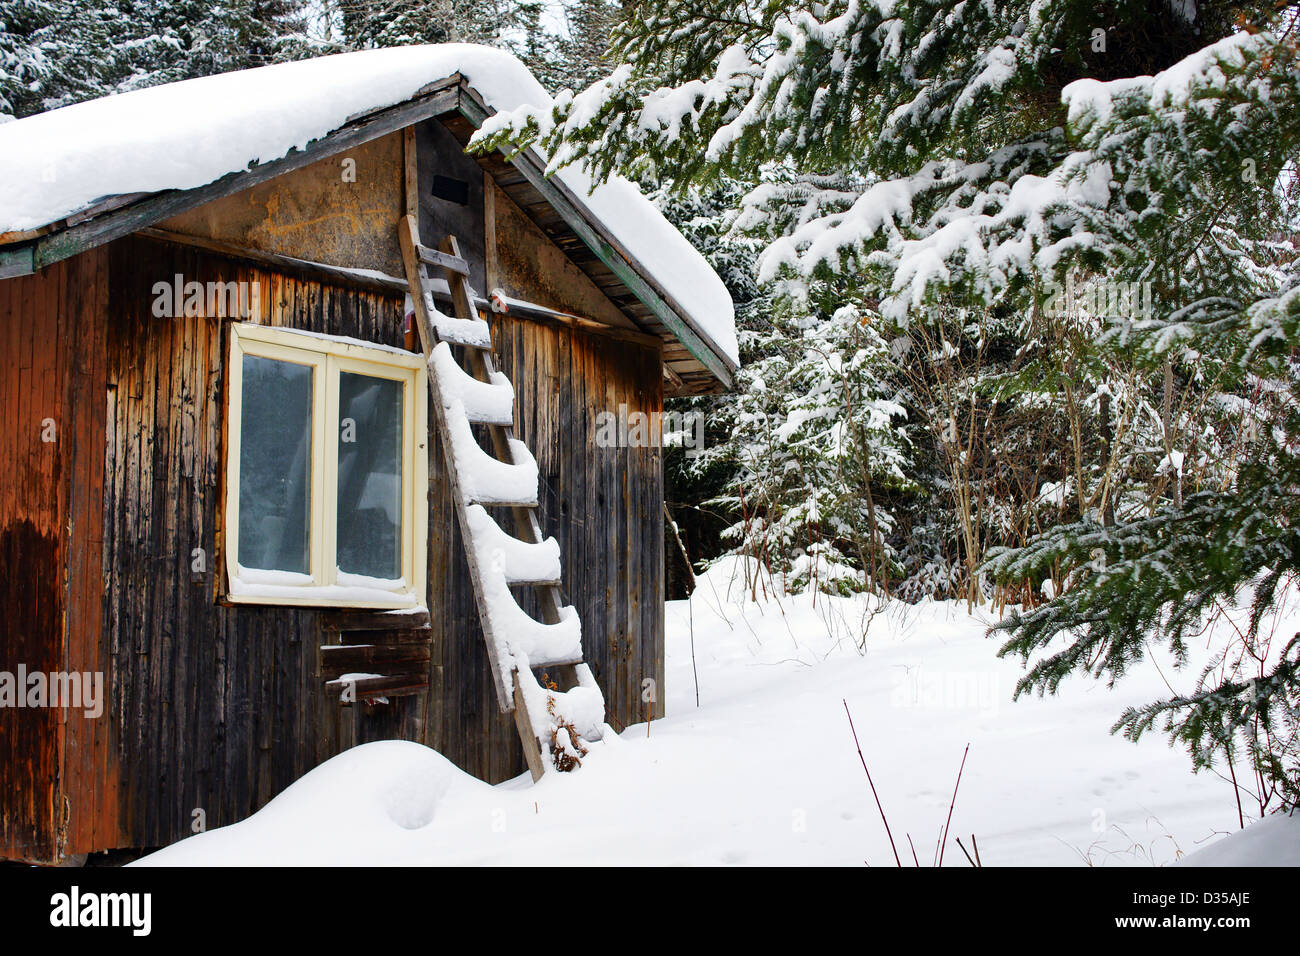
[{"xmin": 225, "ymin": 324, "xmax": 428, "ymax": 609}]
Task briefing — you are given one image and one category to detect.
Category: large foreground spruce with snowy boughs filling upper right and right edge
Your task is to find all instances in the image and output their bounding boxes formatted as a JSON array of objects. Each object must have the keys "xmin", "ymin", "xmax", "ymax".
[{"xmin": 482, "ymin": 0, "xmax": 1300, "ymax": 796}]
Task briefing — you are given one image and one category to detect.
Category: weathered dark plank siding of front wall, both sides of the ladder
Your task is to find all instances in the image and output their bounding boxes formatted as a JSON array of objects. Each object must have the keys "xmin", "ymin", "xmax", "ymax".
[{"xmin": 83, "ymin": 239, "xmax": 663, "ymax": 847}]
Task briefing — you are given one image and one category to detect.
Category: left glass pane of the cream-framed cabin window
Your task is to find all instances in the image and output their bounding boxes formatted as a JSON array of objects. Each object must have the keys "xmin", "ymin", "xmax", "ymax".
[{"xmin": 239, "ymin": 355, "xmax": 312, "ymax": 574}]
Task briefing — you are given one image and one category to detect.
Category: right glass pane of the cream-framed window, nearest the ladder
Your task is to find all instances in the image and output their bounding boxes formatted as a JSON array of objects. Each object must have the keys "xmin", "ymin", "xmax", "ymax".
[{"xmin": 338, "ymin": 372, "xmax": 402, "ymax": 580}]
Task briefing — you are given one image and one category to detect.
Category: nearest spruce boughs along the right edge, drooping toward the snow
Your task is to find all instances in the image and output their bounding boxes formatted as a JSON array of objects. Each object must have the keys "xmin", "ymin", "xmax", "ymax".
[{"xmin": 991, "ymin": 24, "xmax": 1300, "ymax": 805}]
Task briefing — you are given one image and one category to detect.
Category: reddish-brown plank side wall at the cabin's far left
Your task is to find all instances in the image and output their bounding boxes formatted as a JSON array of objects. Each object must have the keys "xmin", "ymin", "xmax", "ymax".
[{"xmin": 0, "ymin": 250, "xmax": 112, "ymax": 861}]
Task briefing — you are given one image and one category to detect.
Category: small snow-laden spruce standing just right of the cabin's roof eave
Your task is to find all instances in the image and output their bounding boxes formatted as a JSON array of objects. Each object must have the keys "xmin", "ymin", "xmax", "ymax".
[{"xmin": 718, "ymin": 299, "xmax": 910, "ymax": 593}]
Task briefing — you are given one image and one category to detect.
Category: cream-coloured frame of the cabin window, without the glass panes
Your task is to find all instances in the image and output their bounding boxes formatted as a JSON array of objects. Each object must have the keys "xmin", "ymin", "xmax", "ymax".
[{"xmin": 224, "ymin": 323, "xmax": 429, "ymax": 610}]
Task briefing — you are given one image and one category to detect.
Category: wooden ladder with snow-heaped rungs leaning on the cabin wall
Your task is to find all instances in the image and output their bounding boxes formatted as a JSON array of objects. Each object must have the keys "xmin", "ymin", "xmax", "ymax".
[{"xmin": 398, "ymin": 215, "xmax": 608, "ymax": 780}]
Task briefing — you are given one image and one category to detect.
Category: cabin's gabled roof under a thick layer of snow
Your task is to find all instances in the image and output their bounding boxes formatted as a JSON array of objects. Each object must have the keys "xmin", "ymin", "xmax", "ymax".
[{"xmin": 0, "ymin": 44, "xmax": 738, "ymax": 392}]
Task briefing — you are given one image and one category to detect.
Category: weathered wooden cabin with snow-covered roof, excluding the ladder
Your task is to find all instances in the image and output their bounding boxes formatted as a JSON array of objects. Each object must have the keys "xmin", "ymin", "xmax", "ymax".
[{"xmin": 0, "ymin": 47, "xmax": 736, "ymax": 862}]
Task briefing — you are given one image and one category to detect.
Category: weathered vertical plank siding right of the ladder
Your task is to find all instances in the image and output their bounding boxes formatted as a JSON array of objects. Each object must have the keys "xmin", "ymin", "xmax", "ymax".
[{"xmin": 494, "ymin": 314, "xmax": 663, "ymax": 730}]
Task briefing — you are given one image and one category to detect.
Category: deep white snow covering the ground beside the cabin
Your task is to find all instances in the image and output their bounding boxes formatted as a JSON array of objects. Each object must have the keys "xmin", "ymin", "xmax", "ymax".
[{"xmin": 142, "ymin": 563, "xmax": 1300, "ymax": 866}]
